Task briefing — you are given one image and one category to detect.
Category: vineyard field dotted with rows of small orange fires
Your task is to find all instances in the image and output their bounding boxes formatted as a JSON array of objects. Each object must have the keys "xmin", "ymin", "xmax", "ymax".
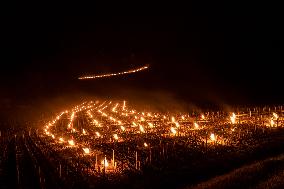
[{"xmin": 2, "ymin": 101, "xmax": 284, "ymax": 188}]
